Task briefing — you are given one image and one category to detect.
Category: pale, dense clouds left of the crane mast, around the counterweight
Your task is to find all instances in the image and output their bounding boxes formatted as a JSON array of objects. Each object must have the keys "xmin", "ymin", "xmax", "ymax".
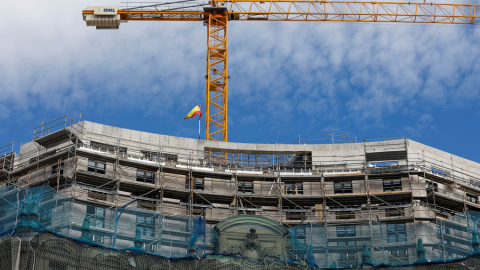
[{"xmin": 0, "ymin": 1, "xmax": 206, "ymax": 120}]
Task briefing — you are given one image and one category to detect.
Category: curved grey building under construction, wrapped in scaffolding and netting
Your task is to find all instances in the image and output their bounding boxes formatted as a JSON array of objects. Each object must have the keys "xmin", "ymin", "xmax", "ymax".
[{"xmin": 0, "ymin": 116, "xmax": 480, "ymax": 269}]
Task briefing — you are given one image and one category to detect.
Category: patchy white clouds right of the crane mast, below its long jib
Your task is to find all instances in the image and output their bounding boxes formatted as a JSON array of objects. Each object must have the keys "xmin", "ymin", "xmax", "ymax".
[{"xmin": 230, "ymin": 19, "xmax": 480, "ymax": 130}]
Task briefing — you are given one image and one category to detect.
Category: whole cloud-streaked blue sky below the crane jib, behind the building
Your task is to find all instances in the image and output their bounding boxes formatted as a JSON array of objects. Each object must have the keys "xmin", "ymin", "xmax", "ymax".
[{"xmin": 0, "ymin": 0, "xmax": 480, "ymax": 162}]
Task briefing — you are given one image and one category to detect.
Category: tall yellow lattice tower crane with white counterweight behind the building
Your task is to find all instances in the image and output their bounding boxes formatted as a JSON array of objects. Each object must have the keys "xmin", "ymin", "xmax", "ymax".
[{"xmin": 83, "ymin": 0, "xmax": 480, "ymax": 141}]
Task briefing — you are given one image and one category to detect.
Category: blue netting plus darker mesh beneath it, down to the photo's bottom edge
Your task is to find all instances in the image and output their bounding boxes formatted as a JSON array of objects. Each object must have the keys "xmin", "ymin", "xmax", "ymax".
[{"xmin": 0, "ymin": 185, "xmax": 480, "ymax": 270}]
